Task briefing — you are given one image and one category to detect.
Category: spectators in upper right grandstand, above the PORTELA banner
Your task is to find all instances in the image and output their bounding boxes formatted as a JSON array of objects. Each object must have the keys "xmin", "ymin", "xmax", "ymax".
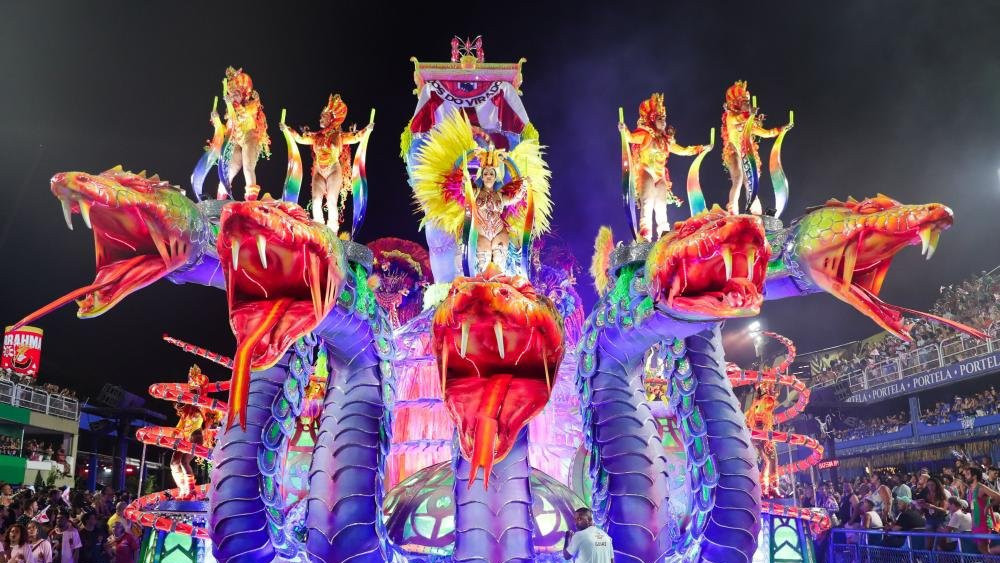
[{"xmin": 813, "ymin": 269, "xmax": 1000, "ymax": 385}]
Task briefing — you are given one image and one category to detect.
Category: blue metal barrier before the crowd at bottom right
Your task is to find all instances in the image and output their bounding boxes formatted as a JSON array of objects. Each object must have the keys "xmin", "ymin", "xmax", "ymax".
[{"xmin": 826, "ymin": 528, "xmax": 1000, "ymax": 563}]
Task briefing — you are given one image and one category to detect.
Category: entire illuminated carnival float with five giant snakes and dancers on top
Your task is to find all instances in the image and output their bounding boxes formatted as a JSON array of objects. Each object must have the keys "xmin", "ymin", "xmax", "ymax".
[{"xmin": 5, "ymin": 38, "xmax": 982, "ymax": 563}]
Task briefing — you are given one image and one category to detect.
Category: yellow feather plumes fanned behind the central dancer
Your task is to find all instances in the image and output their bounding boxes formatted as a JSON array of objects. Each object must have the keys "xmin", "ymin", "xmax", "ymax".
[{"xmin": 410, "ymin": 111, "xmax": 552, "ymax": 237}]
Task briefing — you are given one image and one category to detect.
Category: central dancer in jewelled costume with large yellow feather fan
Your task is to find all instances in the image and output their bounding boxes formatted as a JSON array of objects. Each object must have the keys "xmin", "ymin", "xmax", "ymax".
[{"xmin": 411, "ymin": 112, "xmax": 552, "ymax": 275}]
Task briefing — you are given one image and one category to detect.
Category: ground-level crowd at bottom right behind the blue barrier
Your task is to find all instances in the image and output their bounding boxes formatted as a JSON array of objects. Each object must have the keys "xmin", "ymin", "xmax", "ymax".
[{"xmin": 816, "ymin": 458, "xmax": 1000, "ymax": 553}]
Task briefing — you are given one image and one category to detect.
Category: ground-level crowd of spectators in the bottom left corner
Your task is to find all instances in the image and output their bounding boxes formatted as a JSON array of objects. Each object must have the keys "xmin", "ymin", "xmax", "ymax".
[{"xmin": 0, "ymin": 485, "xmax": 142, "ymax": 563}]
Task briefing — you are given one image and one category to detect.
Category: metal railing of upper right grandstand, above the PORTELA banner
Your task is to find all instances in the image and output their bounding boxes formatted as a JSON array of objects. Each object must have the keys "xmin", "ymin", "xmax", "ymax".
[{"xmin": 814, "ymin": 334, "xmax": 1000, "ymax": 392}]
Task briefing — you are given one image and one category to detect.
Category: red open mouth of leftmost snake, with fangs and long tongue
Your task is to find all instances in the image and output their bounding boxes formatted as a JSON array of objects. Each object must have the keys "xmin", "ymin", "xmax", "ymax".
[{"xmin": 11, "ymin": 171, "xmax": 194, "ymax": 325}]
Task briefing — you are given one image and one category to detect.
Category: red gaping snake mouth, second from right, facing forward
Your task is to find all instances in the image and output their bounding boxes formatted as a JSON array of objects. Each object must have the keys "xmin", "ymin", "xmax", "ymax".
[{"xmin": 646, "ymin": 210, "xmax": 770, "ymax": 320}]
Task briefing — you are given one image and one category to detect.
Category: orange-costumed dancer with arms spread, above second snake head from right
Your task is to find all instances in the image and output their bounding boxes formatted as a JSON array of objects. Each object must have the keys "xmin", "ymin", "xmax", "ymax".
[{"xmin": 618, "ymin": 93, "xmax": 710, "ymax": 241}]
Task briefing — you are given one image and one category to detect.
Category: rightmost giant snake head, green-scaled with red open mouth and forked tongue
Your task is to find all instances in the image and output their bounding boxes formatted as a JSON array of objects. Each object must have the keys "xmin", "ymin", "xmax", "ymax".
[{"xmin": 772, "ymin": 194, "xmax": 985, "ymax": 340}]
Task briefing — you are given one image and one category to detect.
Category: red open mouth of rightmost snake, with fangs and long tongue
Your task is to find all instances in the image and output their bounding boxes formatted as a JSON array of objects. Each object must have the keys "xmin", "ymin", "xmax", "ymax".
[{"xmin": 807, "ymin": 204, "xmax": 986, "ymax": 341}]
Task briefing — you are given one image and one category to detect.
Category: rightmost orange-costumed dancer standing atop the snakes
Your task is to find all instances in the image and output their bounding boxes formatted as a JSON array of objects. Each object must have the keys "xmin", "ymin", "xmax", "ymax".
[{"xmin": 722, "ymin": 81, "xmax": 793, "ymax": 215}]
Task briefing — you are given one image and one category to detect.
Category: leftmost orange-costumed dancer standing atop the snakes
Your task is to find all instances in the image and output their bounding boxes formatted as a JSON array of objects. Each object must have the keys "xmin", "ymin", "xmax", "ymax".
[{"xmin": 212, "ymin": 67, "xmax": 271, "ymax": 200}]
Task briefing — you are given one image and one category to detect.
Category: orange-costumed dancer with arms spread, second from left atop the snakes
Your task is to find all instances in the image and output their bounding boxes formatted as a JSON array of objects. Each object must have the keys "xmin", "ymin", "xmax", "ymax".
[{"xmin": 281, "ymin": 94, "xmax": 374, "ymax": 232}]
